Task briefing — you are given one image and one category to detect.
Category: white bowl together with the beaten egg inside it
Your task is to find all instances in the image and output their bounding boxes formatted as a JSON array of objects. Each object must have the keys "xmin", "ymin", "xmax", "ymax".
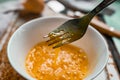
[{"xmin": 7, "ymin": 17, "xmax": 109, "ymax": 80}]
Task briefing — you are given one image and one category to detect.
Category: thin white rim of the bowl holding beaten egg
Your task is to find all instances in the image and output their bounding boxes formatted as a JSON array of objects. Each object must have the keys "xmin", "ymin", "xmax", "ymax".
[{"xmin": 7, "ymin": 16, "xmax": 109, "ymax": 80}]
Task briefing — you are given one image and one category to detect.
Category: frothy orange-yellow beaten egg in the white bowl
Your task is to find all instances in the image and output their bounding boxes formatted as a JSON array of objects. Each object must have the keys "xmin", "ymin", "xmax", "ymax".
[{"xmin": 25, "ymin": 42, "xmax": 88, "ymax": 80}]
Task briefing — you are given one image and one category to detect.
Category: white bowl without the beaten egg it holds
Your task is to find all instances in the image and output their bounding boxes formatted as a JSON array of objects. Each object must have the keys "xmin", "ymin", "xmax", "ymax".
[{"xmin": 7, "ymin": 17, "xmax": 108, "ymax": 80}]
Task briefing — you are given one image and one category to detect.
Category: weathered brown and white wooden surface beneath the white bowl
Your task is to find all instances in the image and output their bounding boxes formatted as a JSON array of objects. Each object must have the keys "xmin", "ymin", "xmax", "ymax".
[{"xmin": 0, "ymin": 6, "xmax": 120, "ymax": 80}]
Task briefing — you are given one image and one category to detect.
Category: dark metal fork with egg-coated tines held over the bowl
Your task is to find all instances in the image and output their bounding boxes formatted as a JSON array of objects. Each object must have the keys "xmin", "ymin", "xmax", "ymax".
[{"xmin": 44, "ymin": 0, "xmax": 116, "ymax": 48}]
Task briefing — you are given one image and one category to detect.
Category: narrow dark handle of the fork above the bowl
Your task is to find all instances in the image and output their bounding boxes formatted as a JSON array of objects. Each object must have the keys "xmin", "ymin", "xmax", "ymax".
[{"xmin": 87, "ymin": 0, "xmax": 116, "ymax": 20}]
